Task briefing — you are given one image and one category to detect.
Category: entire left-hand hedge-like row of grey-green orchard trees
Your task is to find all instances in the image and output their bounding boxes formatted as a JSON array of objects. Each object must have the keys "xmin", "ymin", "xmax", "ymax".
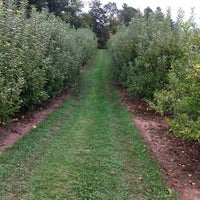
[{"xmin": 0, "ymin": 1, "xmax": 97, "ymax": 123}]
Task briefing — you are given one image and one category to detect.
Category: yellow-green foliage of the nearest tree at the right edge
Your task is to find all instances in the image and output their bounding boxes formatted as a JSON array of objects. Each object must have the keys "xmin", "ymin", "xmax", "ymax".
[{"xmin": 152, "ymin": 17, "xmax": 200, "ymax": 142}]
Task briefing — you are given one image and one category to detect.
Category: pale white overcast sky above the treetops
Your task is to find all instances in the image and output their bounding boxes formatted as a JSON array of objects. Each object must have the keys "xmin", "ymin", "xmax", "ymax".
[{"xmin": 83, "ymin": 0, "xmax": 200, "ymax": 24}]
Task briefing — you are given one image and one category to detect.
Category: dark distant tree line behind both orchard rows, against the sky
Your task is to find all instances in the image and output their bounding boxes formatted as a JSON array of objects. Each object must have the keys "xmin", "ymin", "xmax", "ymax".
[{"xmin": 3, "ymin": 0, "xmax": 164, "ymax": 48}]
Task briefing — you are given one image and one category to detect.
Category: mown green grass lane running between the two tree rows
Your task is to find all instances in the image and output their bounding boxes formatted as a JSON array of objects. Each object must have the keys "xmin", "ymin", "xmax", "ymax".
[{"xmin": 0, "ymin": 50, "xmax": 178, "ymax": 200}]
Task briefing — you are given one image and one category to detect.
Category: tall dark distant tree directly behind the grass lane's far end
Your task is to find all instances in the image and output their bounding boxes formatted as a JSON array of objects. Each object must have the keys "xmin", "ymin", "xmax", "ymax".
[{"xmin": 89, "ymin": 0, "xmax": 109, "ymax": 48}]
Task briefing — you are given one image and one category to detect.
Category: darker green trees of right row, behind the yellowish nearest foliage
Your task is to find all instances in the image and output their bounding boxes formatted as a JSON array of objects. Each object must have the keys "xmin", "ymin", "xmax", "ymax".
[{"xmin": 110, "ymin": 10, "xmax": 182, "ymax": 98}]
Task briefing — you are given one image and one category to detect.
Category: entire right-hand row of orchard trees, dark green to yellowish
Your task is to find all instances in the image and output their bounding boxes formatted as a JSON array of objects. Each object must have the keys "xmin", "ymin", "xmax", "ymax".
[{"xmin": 109, "ymin": 11, "xmax": 200, "ymax": 142}]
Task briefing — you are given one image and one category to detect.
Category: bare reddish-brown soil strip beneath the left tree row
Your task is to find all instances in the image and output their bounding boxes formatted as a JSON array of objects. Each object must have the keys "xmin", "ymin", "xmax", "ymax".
[{"xmin": 0, "ymin": 84, "xmax": 75, "ymax": 154}]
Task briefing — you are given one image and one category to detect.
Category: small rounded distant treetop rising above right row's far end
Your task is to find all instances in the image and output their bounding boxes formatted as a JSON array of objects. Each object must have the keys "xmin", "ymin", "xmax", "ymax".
[{"xmin": 120, "ymin": 3, "xmax": 138, "ymax": 26}]
